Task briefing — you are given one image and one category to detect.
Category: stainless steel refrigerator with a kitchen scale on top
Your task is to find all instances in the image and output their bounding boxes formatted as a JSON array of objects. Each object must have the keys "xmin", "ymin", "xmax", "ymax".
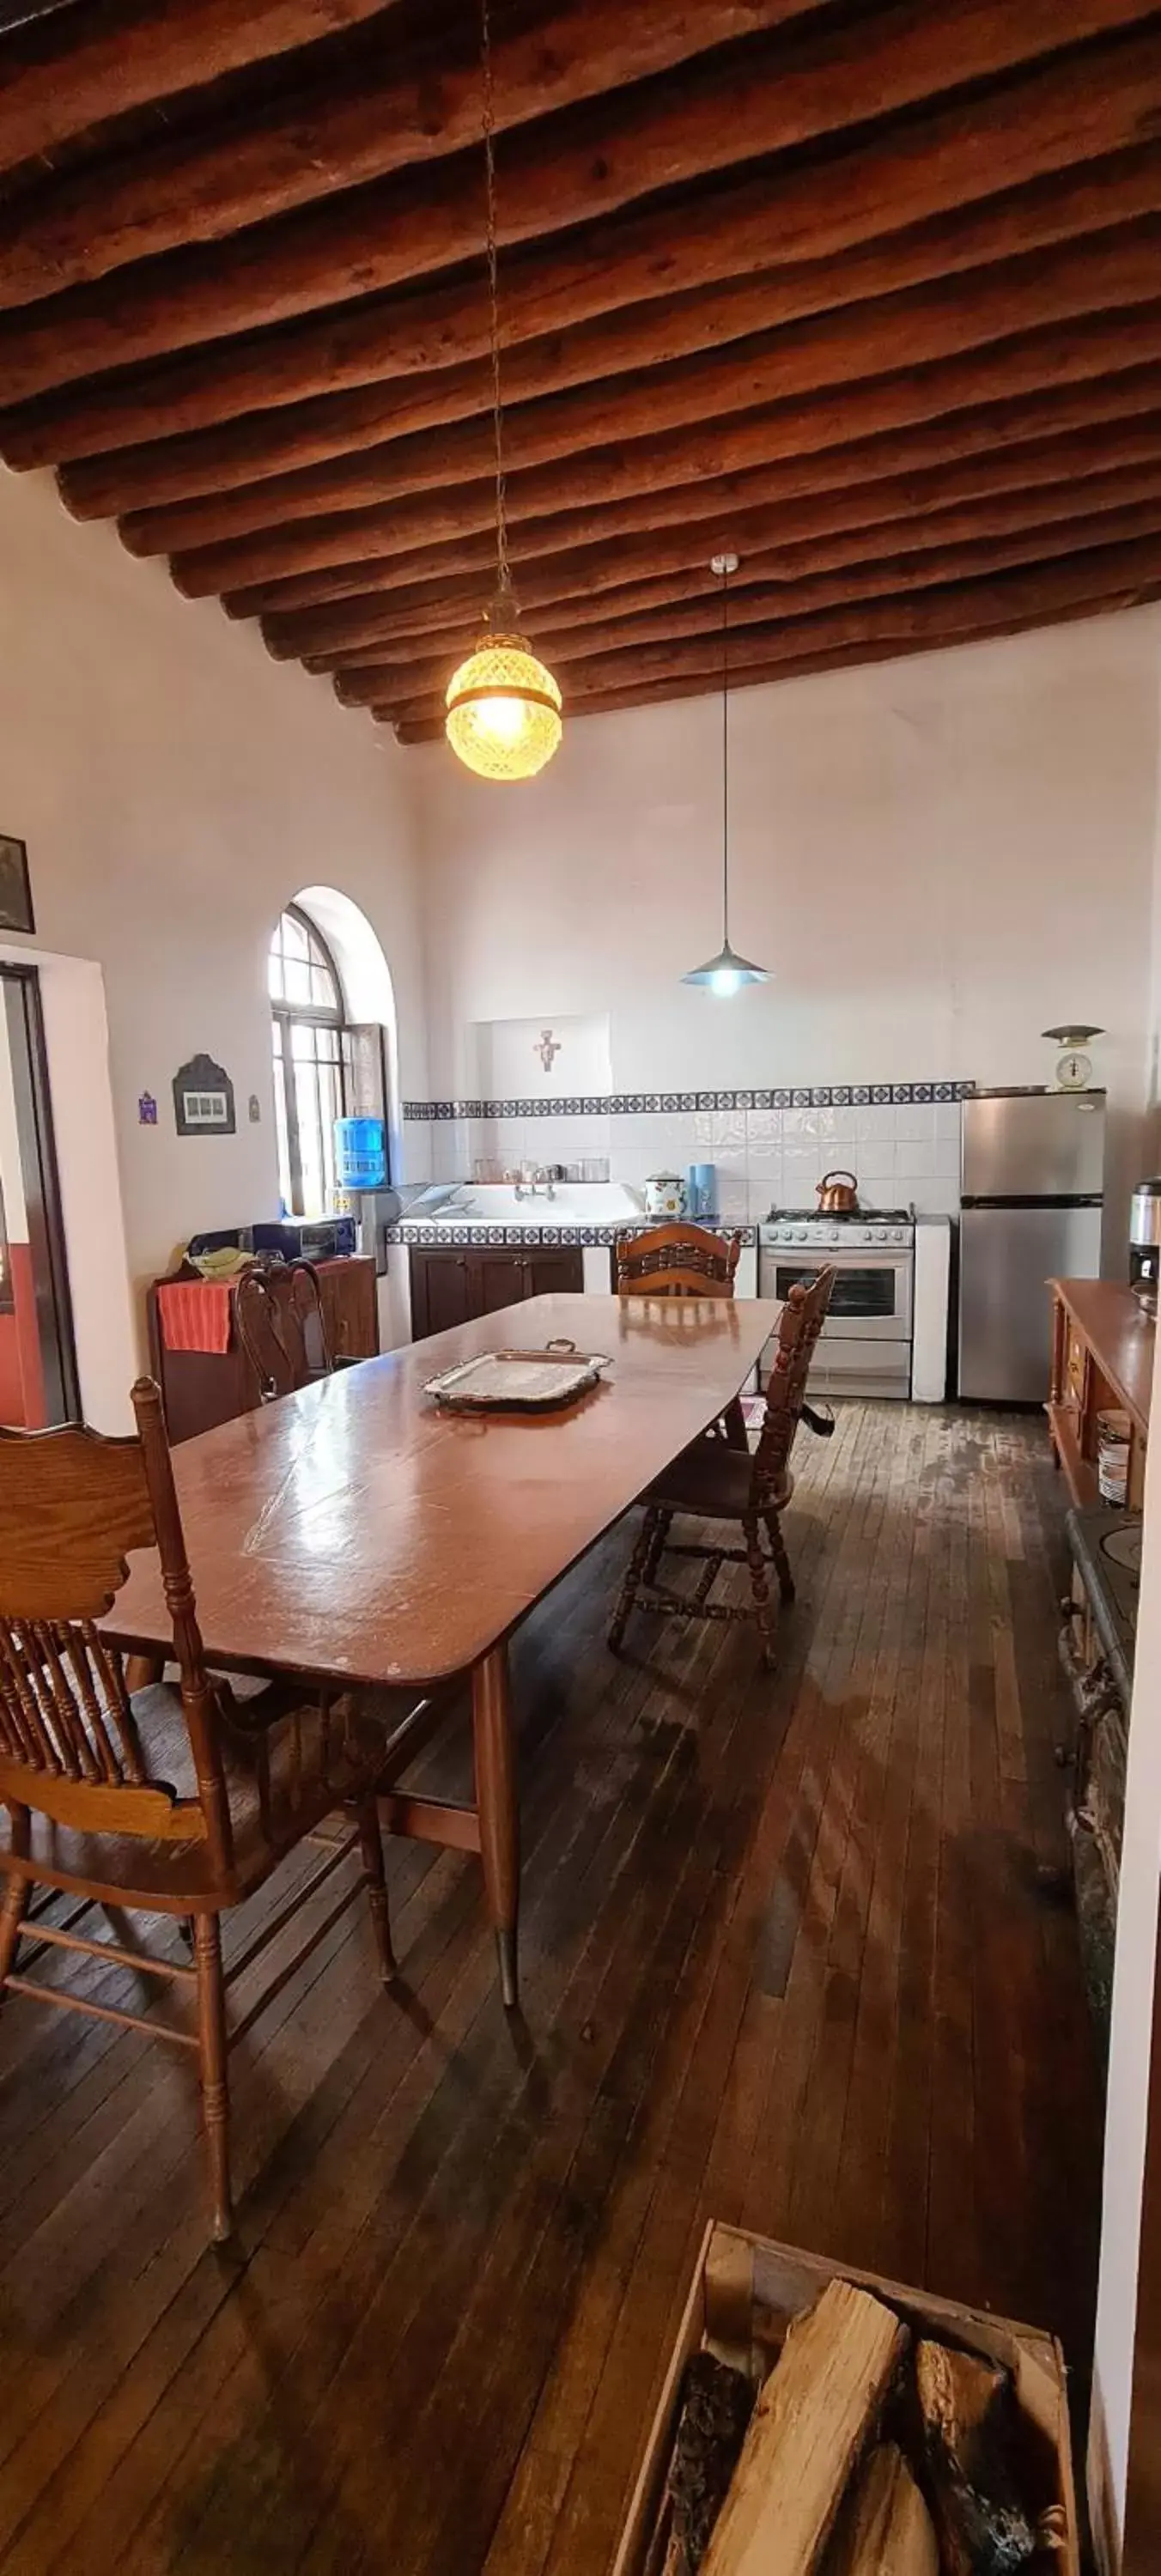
[{"xmin": 960, "ymin": 1092, "xmax": 1104, "ymax": 1404}]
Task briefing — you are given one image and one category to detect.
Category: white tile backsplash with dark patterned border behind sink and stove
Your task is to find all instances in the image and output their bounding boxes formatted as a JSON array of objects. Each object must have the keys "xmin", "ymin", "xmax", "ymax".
[{"xmin": 404, "ymin": 1082, "xmax": 973, "ymax": 1226}]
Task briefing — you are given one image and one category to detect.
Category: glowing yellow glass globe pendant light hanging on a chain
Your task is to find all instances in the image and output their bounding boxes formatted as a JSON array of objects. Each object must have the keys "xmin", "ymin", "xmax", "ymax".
[{"xmin": 446, "ymin": 0, "xmax": 562, "ymax": 781}]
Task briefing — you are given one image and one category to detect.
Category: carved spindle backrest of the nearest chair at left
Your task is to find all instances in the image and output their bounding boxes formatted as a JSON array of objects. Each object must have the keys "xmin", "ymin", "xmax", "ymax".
[{"xmin": 0, "ymin": 1378, "xmax": 229, "ymax": 1868}]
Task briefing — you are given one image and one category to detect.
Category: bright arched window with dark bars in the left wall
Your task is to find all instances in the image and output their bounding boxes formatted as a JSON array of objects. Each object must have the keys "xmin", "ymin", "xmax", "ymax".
[{"xmin": 268, "ymin": 904, "xmax": 348, "ymax": 1216}]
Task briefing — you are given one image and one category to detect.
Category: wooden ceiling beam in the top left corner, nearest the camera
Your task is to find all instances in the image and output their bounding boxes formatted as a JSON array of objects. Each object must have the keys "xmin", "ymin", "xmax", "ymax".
[{"xmin": 0, "ymin": 0, "xmax": 406, "ymax": 173}]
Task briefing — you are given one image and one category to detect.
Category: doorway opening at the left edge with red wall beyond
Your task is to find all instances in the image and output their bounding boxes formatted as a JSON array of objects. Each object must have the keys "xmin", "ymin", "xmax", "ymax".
[{"xmin": 0, "ymin": 966, "xmax": 80, "ymax": 1430}]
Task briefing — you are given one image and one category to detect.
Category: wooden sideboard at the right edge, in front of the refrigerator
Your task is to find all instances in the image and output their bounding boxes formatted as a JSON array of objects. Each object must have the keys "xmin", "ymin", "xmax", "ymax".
[{"xmin": 1048, "ymin": 1280, "xmax": 1156, "ymax": 1512}]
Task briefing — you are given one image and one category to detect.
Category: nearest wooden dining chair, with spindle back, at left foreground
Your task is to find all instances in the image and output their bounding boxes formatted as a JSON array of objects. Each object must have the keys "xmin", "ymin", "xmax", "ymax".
[{"xmin": 0, "ymin": 1378, "xmax": 417, "ymax": 2239}]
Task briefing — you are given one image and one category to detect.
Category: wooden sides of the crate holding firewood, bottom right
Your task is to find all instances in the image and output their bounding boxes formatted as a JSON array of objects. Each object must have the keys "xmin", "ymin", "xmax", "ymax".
[{"xmin": 612, "ymin": 2221, "xmax": 1081, "ymax": 2576}]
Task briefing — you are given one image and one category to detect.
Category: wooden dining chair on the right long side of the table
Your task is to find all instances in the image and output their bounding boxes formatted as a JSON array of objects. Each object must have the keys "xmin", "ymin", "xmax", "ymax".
[{"xmin": 607, "ymin": 1270, "xmax": 834, "ymax": 1667}]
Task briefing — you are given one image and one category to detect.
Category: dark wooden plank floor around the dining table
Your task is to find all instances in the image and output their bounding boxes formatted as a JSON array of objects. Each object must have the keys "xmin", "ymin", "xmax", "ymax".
[{"xmin": 0, "ymin": 1404, "xmax": 1099, "ymax": 2576}]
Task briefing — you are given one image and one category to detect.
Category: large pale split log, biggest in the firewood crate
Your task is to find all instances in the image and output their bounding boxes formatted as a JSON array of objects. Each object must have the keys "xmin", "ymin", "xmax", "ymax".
[{"xmin": 702, "ymin": 2280, "xmax": 909, "ymax": 2576}]
